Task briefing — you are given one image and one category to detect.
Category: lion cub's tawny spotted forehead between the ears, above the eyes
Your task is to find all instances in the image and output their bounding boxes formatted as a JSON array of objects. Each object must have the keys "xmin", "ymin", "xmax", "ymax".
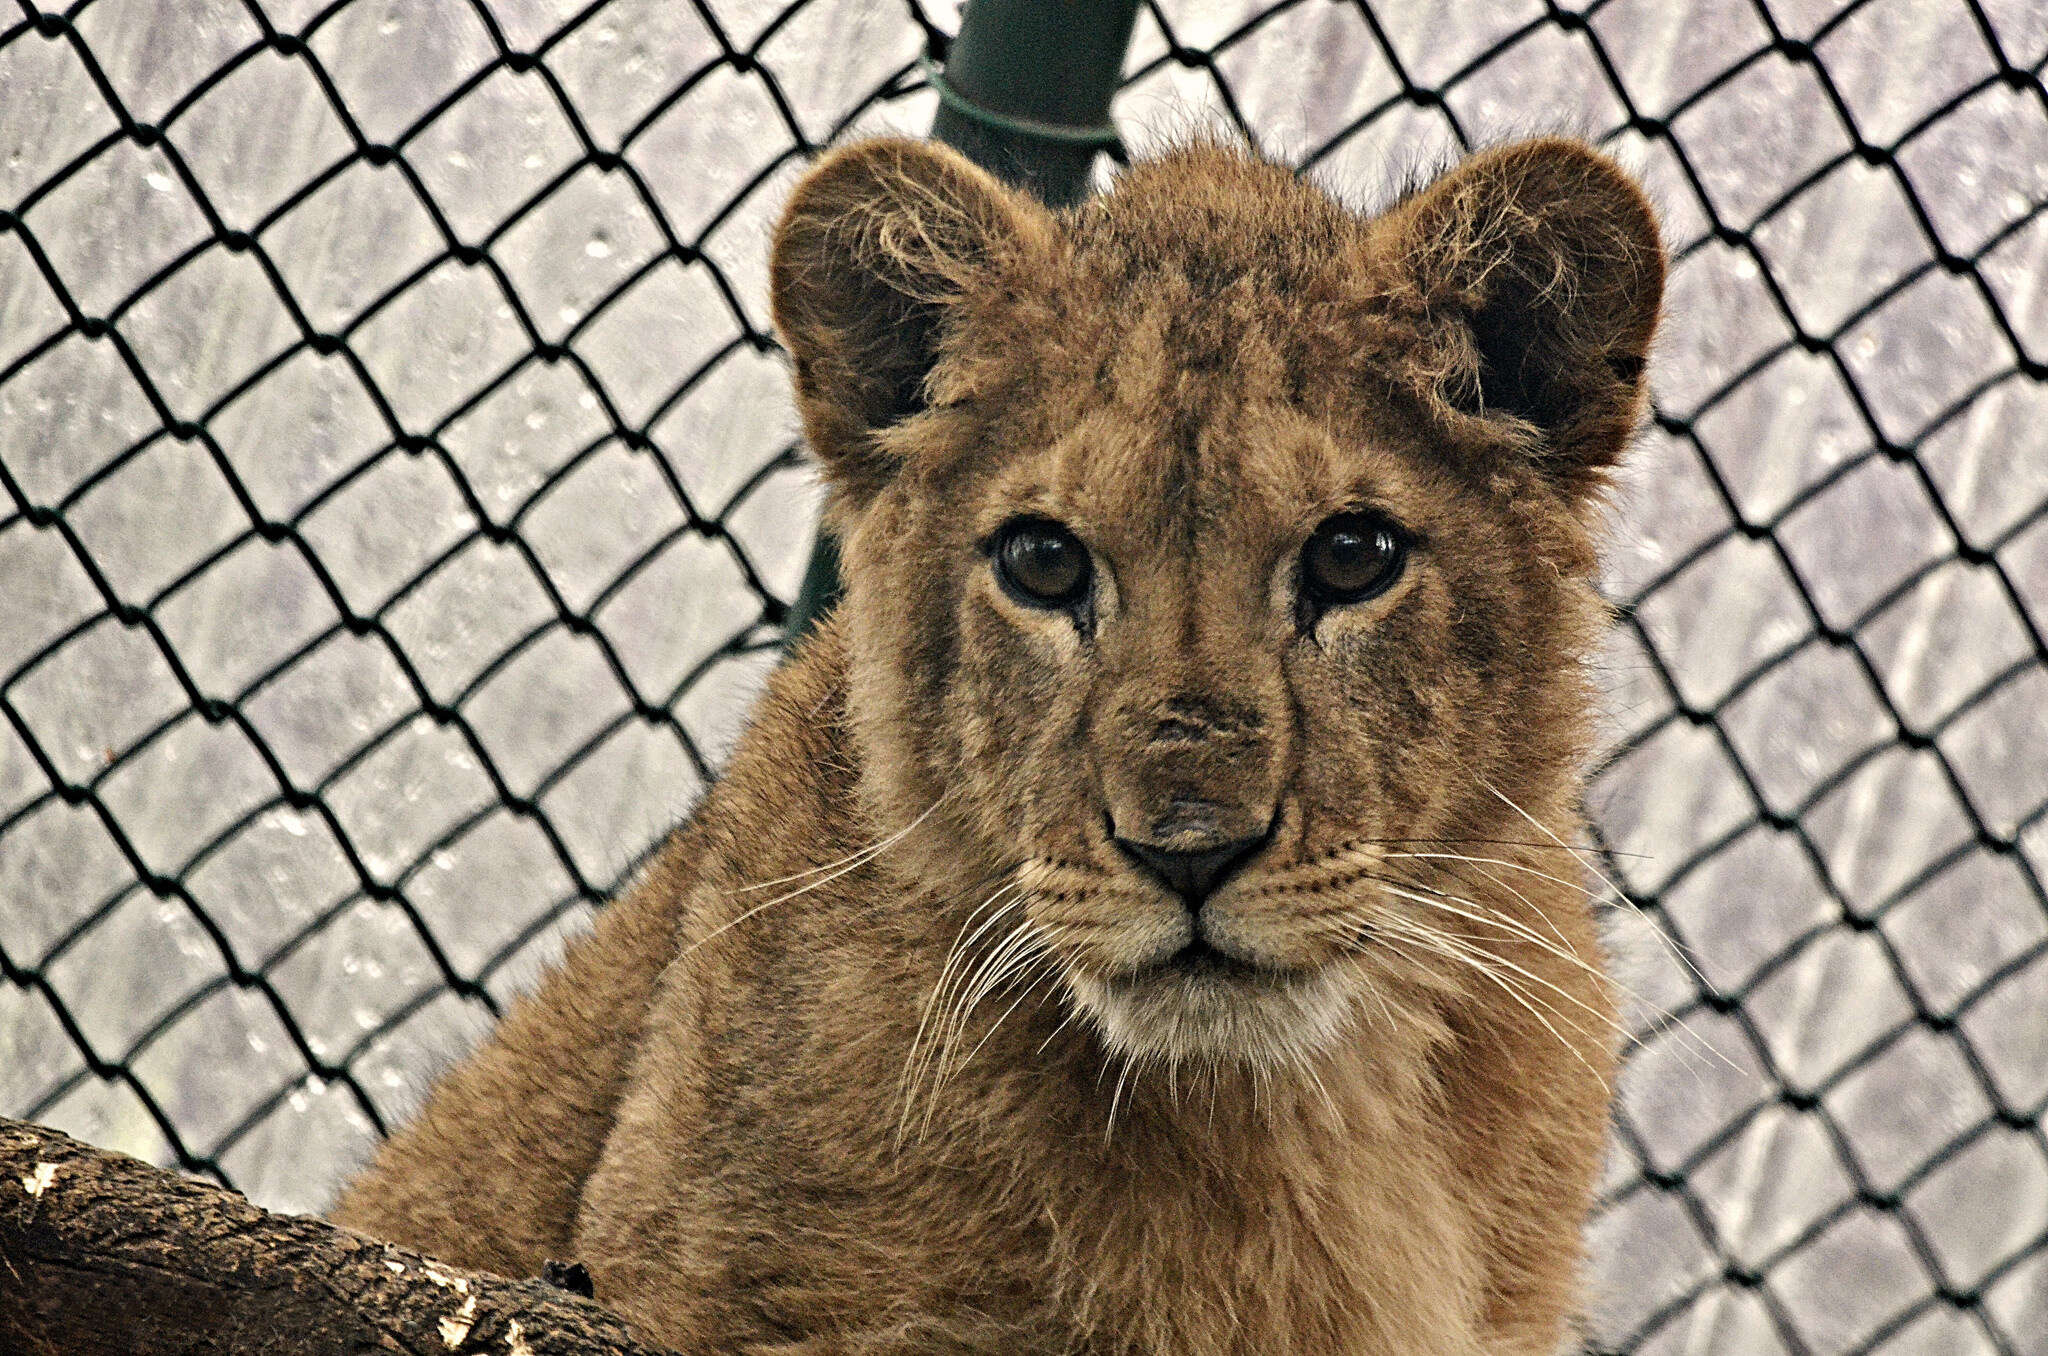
[{"xmin": 950, "ymin": 147, "xmax": 1415, "ymax": 545}]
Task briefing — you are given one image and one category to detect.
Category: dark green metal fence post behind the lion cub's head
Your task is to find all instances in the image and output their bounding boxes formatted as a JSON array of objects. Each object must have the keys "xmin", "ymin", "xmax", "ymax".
[{"xmin": 788, "ymin": 0, "xmax": 1139, "ymax": 641}]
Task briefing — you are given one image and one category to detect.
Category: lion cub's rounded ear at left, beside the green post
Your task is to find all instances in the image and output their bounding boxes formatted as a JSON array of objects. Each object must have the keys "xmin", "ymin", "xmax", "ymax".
[{"xmin": 768, "ymin": 139, "xmax": 1051, "ymax": 506}]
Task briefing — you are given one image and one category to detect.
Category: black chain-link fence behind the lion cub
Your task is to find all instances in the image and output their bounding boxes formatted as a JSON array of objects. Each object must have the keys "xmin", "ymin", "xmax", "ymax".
[{"xmin": 0, "ymin": 0, "xmax": 2048, "ymax": 1356}]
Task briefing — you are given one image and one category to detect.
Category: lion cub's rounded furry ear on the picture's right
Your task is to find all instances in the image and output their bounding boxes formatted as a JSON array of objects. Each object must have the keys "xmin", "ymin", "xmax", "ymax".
[{"xmin": 1376, "ymin": 137, "xmax": 1665, "ymax": 494}]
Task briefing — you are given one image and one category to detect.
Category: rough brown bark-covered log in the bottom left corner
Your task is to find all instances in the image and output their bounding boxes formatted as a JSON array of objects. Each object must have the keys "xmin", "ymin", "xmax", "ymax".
[{"xmin": 0, "ymin": 1120, "xmax": 688, "ymax": 1356}]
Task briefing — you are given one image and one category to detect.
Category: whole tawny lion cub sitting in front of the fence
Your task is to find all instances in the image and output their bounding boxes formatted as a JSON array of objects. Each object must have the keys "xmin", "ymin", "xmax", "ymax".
[{"xmin": 334, "ymin": 139, "xmax": 1663, "ymax": 1356}]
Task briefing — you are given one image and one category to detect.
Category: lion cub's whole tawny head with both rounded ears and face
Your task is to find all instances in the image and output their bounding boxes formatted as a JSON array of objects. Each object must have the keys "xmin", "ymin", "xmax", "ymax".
[{"xmin": 772, "ymin": 139, "xmax": 1663, "ymax": 1061}]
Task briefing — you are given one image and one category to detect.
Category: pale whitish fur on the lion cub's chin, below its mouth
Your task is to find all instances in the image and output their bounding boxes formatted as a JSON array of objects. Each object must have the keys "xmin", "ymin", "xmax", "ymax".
[{"xmin": 1069, "ymin": 971, "xmax": 1352, "ymax": 1069}]
